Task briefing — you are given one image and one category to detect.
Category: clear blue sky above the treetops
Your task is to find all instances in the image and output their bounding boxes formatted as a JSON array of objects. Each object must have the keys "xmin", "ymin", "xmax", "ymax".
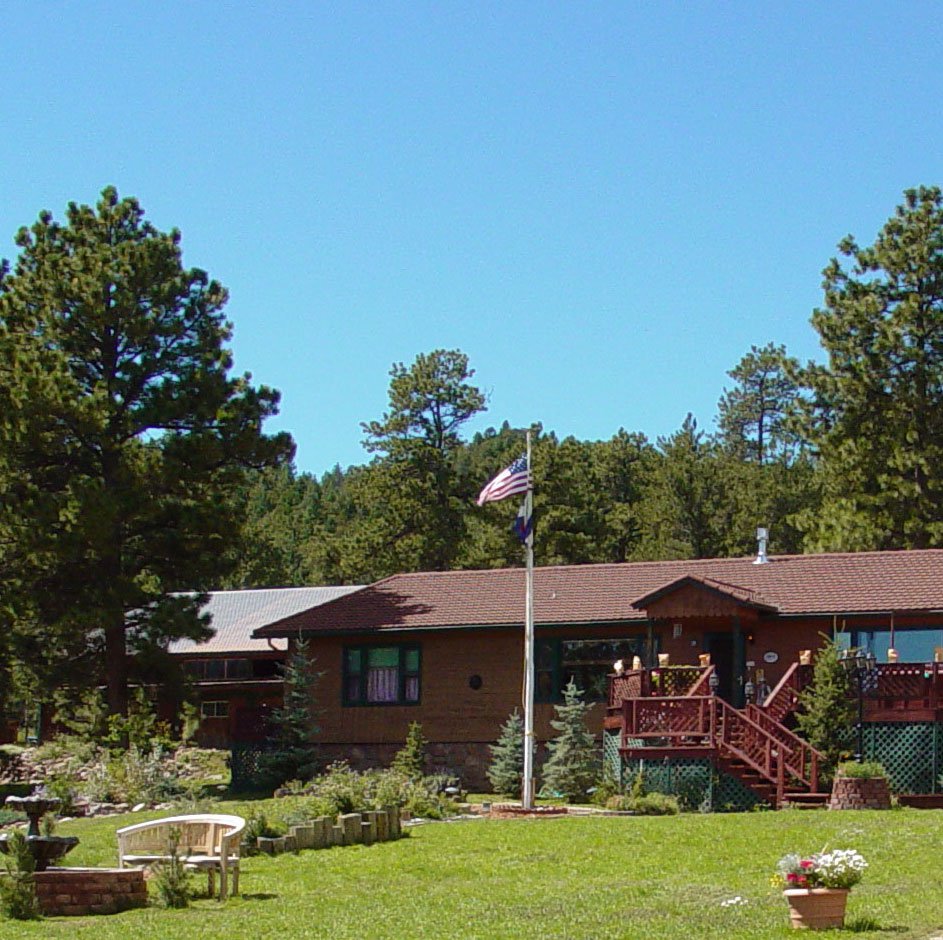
[{"xmin": 0, "ymin": 0, "xmax": 943, "ymax": 474}]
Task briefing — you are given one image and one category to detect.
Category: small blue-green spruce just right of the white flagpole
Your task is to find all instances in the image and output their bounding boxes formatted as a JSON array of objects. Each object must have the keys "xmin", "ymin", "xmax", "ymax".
[{"xmin": 541, "ymin": 678, "xmax": 600, "ymax": 800}]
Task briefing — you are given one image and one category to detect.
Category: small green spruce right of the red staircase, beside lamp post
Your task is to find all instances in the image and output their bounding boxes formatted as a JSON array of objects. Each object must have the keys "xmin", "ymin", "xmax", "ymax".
[{"xmin": 796, "ymin": 640, "xmax": 855, "ymax": 779}]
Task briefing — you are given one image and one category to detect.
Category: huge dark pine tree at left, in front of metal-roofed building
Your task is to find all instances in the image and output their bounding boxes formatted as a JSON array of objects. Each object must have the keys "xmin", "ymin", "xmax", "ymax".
[{"xmin": 0, "ymin": 188, "xmax": 292, "ymax": 714}]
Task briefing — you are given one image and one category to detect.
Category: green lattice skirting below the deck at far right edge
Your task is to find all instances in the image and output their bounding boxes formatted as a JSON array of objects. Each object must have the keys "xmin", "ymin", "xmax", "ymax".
[{"xmin": 864, "ymin": 721, "xmax": 943, "ymax": 793}]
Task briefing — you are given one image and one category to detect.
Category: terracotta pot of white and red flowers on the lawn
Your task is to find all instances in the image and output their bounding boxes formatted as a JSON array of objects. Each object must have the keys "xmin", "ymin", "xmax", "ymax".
[{"xmin": 774, "ymin": 849, "xmax": 868, "ymax": 930}]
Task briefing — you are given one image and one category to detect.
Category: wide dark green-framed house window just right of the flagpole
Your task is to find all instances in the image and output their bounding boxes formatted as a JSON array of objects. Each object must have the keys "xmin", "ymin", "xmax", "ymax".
[{"xmin": 534, "ymin": 634, "xmax": 646, "ymax": 702}]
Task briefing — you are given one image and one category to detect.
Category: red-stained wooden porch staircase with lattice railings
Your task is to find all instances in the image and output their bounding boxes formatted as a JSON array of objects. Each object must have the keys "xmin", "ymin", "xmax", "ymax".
[{"xmin": 607, "ymin": 664, "xmax": 827, "ymax": 809}]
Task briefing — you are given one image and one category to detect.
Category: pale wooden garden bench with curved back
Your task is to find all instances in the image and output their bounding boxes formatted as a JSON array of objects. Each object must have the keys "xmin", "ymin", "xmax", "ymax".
[{"xmin": 116, "ymin": 813, "xmax": 246, "ymax": 901}]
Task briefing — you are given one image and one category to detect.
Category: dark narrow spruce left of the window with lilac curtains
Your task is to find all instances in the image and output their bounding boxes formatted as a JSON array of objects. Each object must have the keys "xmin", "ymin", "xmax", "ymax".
[{"xmin": 261, "ymin": 640, "xmax": 322, "ymax": 784}]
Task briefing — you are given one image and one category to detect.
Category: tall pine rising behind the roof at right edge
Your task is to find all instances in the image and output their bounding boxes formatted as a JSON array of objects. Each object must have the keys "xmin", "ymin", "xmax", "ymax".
[{"xmin": 801, "ymin": 187, "xmax": 943, "ymax": 551}]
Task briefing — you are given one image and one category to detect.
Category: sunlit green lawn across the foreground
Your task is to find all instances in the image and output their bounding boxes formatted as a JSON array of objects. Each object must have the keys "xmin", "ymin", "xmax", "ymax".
[{"xmin": 0, "ymin": 804, "xmax": 943, "ymax": 940}]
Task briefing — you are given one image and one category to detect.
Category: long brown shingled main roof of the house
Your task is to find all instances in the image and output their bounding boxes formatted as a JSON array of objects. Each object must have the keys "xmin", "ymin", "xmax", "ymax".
[{"xmin": 255, "ymin": 549, "xmax": 943, "ymax": 636}]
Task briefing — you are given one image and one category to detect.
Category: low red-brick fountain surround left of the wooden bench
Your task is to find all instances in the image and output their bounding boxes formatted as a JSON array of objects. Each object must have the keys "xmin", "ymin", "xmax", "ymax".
[{"xmin": 34, "ymin": 868, "xmax": 147, "ymax": 917}]
